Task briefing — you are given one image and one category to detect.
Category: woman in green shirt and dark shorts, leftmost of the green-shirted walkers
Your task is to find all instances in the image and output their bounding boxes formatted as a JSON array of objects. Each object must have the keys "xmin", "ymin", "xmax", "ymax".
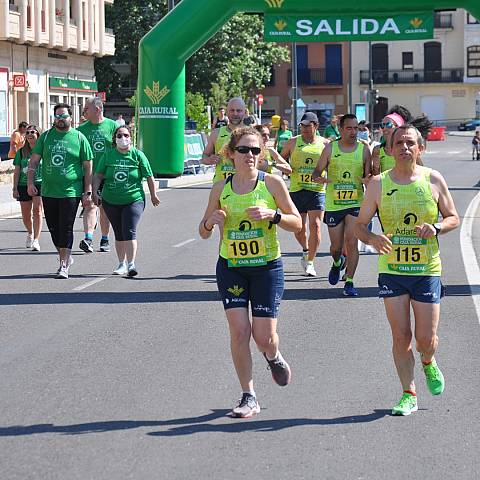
[{"xmin": 13, "ymin": 125, "xmax": 43, "ymax": 252}]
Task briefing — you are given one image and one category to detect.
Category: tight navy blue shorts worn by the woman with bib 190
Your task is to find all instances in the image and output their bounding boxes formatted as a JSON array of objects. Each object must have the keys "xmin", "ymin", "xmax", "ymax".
[{"xmin": 217, "ymin": 257, "xmax": 284, "ymax": 318}]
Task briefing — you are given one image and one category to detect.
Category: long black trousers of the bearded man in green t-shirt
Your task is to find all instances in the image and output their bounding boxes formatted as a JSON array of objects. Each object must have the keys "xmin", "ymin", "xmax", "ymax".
[{"xmin": 42, "ymin": 197, "xmax": 80, "ymax": 250}]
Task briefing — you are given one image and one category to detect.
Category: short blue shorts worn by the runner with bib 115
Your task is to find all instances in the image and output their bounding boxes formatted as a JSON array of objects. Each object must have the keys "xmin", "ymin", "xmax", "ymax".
[{"xmin": 378, "ymin": 273, "xmax": 445, "ymax": 303}]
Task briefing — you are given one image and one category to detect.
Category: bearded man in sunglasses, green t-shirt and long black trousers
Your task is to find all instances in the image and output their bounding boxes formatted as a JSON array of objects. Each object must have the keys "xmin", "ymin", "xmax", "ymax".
[{"xmin": 28, "ymin": 103, "xmax": 93, "ymax": 278}]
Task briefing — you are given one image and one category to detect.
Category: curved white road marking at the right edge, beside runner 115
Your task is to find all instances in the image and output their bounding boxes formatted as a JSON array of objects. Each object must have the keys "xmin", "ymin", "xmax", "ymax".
[{"xmin": 460, "ymin": 193, "xmax": 480, "ymax": 324}]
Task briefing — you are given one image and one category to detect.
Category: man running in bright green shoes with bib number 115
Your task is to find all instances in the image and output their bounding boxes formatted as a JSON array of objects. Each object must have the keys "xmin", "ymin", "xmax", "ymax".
[{"xmin": 356, "ymin": 124, "xmax": 460, "ymax": 415}]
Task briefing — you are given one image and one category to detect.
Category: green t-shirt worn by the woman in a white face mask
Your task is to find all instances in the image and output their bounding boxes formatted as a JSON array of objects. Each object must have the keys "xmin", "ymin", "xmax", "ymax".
[{"xmin": 95, "ymin": 147, "xmax": 153, "ymax": 205}]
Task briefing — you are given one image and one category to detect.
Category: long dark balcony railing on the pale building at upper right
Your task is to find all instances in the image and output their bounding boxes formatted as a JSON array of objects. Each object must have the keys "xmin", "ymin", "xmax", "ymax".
[{"xmin": 360, "ymin": 68, "xmax": 464, "ymax": 85}]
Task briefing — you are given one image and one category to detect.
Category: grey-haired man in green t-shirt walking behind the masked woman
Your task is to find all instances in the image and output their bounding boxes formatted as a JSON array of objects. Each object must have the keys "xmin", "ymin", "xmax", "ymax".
[{"xmin": 78, "ymin": 97, "xmax": 117, "ymax": 253}]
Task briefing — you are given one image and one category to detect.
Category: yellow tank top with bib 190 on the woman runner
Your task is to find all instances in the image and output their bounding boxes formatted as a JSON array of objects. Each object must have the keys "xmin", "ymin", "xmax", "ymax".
[{"xmin": 220, "ymin": 172, "xmax": 281, "ymax": 267}]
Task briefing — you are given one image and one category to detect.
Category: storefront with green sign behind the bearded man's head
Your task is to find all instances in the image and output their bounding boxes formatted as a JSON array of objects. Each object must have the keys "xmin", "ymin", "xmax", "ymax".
[{"xmin": 48, "ymin": 77, "xmax": 98, "ymax": 126}]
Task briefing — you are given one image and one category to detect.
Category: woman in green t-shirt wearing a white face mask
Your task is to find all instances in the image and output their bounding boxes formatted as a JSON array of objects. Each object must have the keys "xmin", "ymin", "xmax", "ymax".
[{"xmin": 92, "ymin": 125, "xmax": 160, "ymax": 277}]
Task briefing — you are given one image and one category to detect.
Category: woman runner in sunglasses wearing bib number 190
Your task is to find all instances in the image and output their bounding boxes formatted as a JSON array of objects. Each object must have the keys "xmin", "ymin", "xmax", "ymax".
[{"xmin": 199, "ymin": 127, "xmax": 301, "ymax": 418}]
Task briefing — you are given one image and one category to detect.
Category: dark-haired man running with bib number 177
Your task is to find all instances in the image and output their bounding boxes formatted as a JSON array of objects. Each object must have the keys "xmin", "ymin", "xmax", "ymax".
[{"xmin": 314, "ymin": 114, "xmax": 371, "ymax": 296}]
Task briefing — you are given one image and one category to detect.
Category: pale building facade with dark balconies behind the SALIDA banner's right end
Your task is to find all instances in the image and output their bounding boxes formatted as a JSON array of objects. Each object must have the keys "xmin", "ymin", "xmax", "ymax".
[{"xmin": 352, "ymin": 9, "xmax": 480, "ymax": 124}]
